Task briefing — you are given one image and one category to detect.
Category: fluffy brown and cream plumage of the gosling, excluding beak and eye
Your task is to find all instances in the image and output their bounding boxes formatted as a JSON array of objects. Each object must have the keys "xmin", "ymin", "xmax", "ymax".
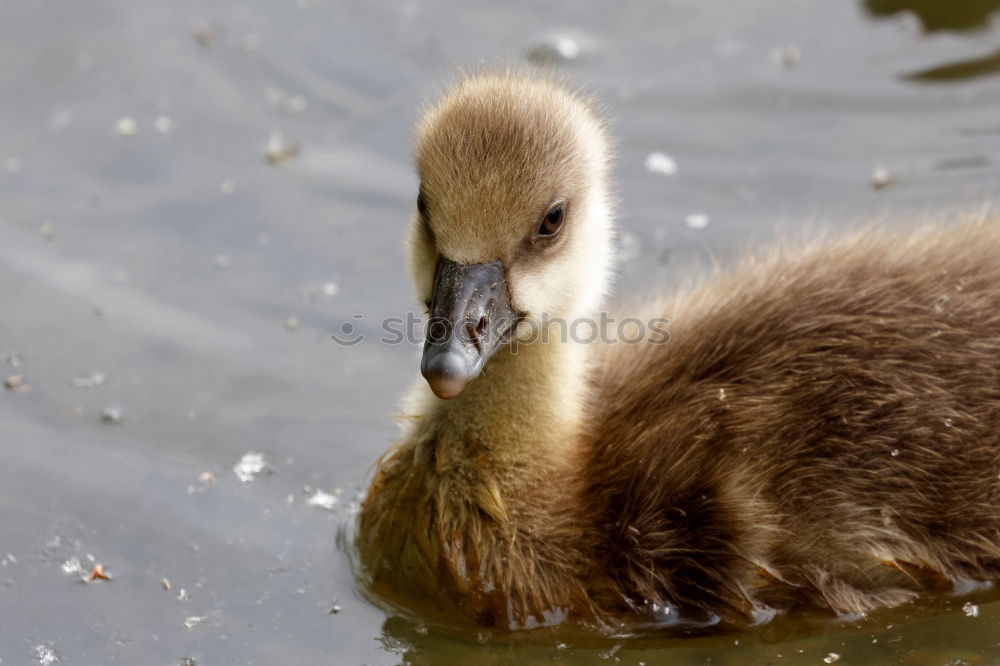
[{"xmin": 357, "ymin": 74, "xmax": 1000, "ymax": 629}]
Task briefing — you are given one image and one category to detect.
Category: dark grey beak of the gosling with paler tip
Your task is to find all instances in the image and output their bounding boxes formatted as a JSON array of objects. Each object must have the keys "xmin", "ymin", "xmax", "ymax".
[{"xmin": 420, "ymin": 257, "xmax": 518, "ymax": 400}]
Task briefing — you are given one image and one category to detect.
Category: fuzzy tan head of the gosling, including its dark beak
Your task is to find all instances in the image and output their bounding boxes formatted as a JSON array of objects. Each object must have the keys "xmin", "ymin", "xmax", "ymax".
[{"xmin": 410, "ymin": 73, "xmax": 611, "ymax": 399}]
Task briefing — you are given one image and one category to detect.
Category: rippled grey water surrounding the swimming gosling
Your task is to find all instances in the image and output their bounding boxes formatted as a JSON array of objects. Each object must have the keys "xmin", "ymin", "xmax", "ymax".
[{"xmin": 0, "ymin": 0, "xmax": 1000, "ymax": 665}]
